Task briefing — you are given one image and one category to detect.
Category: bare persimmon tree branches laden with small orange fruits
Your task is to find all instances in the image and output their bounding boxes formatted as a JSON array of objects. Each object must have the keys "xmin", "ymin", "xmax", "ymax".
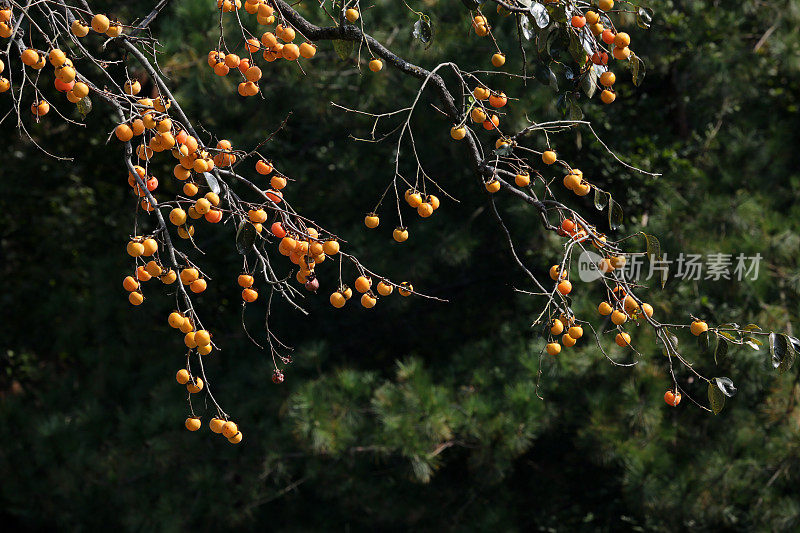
[{"xmin": 0, "ymin": 0, "xmax": 800, "ymax": 443}]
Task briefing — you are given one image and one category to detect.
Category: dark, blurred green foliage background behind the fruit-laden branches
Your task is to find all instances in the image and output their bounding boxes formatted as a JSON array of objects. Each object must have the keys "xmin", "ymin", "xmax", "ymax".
[{"xmin": 0, "ymin": 0, "xmax": 800, "ymax": 531}]
